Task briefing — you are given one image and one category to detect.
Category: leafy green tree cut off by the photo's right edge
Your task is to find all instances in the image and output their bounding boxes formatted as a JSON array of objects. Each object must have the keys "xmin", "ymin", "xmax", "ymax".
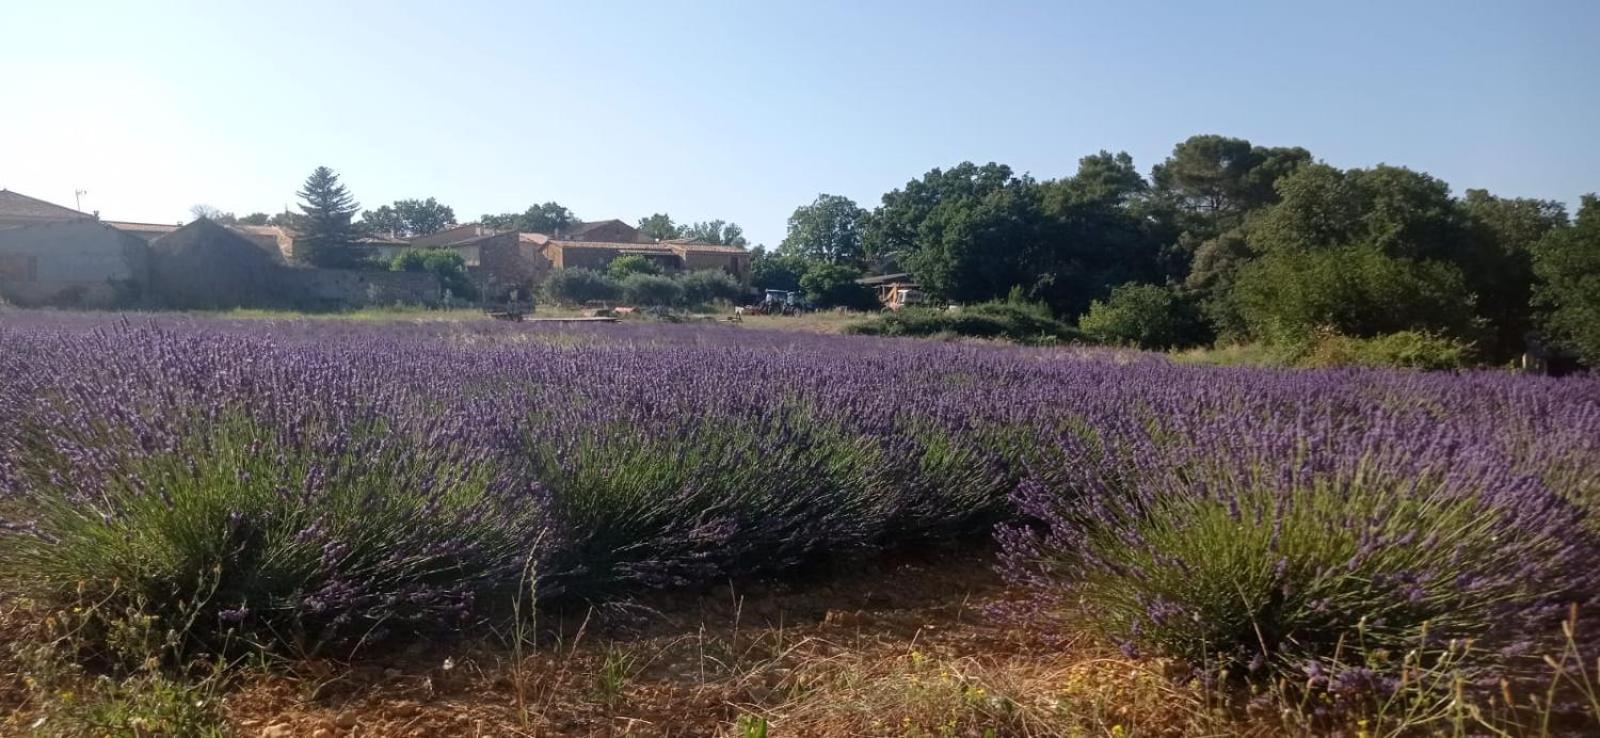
[{"xmin": 1533, "ymin": 194, "xmax": 1600, "ymax": 367}]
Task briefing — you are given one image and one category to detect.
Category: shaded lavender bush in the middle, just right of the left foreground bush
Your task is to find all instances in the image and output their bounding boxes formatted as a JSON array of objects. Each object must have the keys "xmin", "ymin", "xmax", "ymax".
[{"xmin": 526, "ymin": 410, "xmax": 893, "ymax": 597}]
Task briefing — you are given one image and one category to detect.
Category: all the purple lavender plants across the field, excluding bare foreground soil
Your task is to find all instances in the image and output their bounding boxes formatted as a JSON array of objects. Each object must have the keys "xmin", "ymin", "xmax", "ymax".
[{"xmin": 0, "ymin": 317, "xmax": 1600, "ymax": 681}]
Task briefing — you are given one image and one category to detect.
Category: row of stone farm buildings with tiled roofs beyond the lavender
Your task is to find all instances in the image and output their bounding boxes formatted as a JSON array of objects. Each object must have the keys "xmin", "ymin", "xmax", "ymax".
[{"xmin": 0, "ymin": 191, "xmax": 750, "ymax": 309}]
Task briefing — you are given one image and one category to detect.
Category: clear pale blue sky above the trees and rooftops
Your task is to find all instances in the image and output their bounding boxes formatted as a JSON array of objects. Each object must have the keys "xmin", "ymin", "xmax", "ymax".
[{"xmin": 0, "ymin": 0, "xmax": 1600, "ymax": 245}]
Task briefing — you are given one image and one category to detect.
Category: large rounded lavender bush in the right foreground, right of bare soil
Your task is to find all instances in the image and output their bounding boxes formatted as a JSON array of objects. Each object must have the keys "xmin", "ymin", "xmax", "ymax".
[{"xmin": 1003, "ymin": 390, "xmax": 1600, "ymax": 690}]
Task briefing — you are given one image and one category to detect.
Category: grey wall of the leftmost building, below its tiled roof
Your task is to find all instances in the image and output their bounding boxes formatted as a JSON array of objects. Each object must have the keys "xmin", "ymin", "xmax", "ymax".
[{"xmin": 0, "ymin": 221, "xmax": 149, "ymax": 309}]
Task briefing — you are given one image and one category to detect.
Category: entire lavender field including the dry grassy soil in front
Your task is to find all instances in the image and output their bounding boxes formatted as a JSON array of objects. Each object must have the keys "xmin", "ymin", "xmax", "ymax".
[{"xmin": 0, "ymin": 314, "xmax": 1600, "ymax": 736}]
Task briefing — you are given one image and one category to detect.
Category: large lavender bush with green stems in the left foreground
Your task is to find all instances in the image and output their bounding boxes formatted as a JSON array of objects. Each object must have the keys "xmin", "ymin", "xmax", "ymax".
[{"xmin": 0, "ymin": 408, "xmax": 542, "ymax": 648}]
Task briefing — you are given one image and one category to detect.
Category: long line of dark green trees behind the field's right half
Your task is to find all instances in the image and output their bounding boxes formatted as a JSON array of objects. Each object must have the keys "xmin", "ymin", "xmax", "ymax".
[{"xmin": 752, "ymin": 134, "xmax": 1600, "ymax": 362}]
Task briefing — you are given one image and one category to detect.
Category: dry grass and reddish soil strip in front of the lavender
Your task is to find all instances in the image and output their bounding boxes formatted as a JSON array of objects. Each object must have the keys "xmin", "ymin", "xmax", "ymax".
[{"xmin": 0, "ymin": 551, "xmax": 1600, "ymax": 729}]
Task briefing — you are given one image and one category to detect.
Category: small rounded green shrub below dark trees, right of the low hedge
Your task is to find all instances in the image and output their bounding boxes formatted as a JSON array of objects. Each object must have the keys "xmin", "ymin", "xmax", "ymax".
[{"xmin": 1078, "ymin": 283, "xmax": 1198, "ymax": 349}]
